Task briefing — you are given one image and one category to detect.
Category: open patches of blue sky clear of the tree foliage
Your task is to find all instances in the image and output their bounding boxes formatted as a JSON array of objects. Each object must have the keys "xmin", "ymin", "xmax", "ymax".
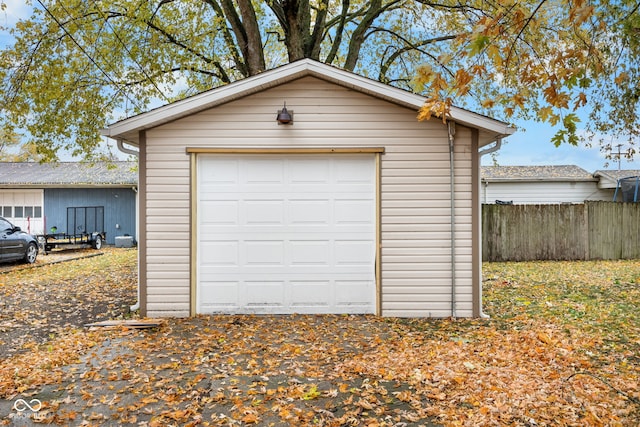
[{"xmin": 0, "ymin": 0, "xmax": 640, "ymax": 172}]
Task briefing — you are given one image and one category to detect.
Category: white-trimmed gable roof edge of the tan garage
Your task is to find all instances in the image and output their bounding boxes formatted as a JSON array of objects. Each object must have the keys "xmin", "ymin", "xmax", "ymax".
[{"xmin": 101, "ymin": 59, "xmax": 515, "ymax": 146}]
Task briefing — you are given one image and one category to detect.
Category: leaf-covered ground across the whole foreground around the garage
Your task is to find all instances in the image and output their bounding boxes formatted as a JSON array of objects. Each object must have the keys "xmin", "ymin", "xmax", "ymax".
[{"xmin": 0, "ymin": 249, "xmax": 640, "ymax": 426}]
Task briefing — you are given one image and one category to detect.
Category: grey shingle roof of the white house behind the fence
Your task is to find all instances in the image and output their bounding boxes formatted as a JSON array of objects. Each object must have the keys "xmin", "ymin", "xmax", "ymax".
[{"xmin": 480, "ymin": 165, "xmax": 597, "ymax": 182}]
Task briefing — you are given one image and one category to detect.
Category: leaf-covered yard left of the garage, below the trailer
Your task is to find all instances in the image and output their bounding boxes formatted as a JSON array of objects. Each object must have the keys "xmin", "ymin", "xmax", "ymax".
[{"xmin": 0, "ymin": 249, "xmax": 137, "ymax": 357}]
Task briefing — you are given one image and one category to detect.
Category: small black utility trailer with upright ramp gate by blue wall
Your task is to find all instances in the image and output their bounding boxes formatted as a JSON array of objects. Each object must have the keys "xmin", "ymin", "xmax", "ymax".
[{"xmin": 36, "ymin": 206, "xmax": 107, "ymax": 255}]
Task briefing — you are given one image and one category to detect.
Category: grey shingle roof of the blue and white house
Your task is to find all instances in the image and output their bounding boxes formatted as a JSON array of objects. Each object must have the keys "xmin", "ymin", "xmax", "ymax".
[{"xmin": 0, "ymin": 162, "xmax": 138, "ymax": 188}]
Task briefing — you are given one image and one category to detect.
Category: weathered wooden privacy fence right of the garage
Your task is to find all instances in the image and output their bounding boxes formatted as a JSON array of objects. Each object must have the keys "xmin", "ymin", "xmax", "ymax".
[{"xmin": 482, "ymin": 202, "xmax": 640, "ymax": 261}]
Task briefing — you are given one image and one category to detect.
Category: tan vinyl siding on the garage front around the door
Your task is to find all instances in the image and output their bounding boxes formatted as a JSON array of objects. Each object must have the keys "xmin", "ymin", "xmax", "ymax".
[{"xmin": 145, "ymin": 77, "xmax": 473, "ymax": 317}]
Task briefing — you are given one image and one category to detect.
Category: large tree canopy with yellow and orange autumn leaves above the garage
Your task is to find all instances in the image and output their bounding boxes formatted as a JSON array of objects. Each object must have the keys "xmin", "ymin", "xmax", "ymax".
[{"xmin": 0, "ymin": 0, "xmax": 640, "ymax": 160}]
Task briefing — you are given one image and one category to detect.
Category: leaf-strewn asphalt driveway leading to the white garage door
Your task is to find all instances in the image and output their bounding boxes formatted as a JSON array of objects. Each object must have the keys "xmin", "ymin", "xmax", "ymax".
[{"xmin": 0, "ymin": 316, "xmax": 444, "ymax": 426}]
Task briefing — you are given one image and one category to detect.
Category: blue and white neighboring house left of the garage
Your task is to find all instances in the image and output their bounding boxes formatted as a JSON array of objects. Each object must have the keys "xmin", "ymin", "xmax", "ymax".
[{"xmin": 0, "ymin": 162, "xmax": 138, "ymax": 244}]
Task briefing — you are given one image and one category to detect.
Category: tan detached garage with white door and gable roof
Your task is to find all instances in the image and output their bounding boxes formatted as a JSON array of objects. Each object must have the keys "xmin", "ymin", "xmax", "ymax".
[{"xmin": 103, "ymin": 59, "xmax": 514, "ymax": 317}]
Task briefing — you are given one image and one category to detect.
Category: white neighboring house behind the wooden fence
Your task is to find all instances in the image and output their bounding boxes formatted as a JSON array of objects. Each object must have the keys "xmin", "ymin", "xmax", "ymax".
[{"xmin": 481, "ymin": 165, "xmax": 615, "ymax": 204}]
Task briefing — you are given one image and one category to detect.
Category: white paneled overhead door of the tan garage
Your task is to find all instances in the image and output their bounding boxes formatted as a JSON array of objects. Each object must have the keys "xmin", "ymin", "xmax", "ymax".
[{"xmin": 196, "ymin": 155, "xmax": 376, "ymax": 314}]
